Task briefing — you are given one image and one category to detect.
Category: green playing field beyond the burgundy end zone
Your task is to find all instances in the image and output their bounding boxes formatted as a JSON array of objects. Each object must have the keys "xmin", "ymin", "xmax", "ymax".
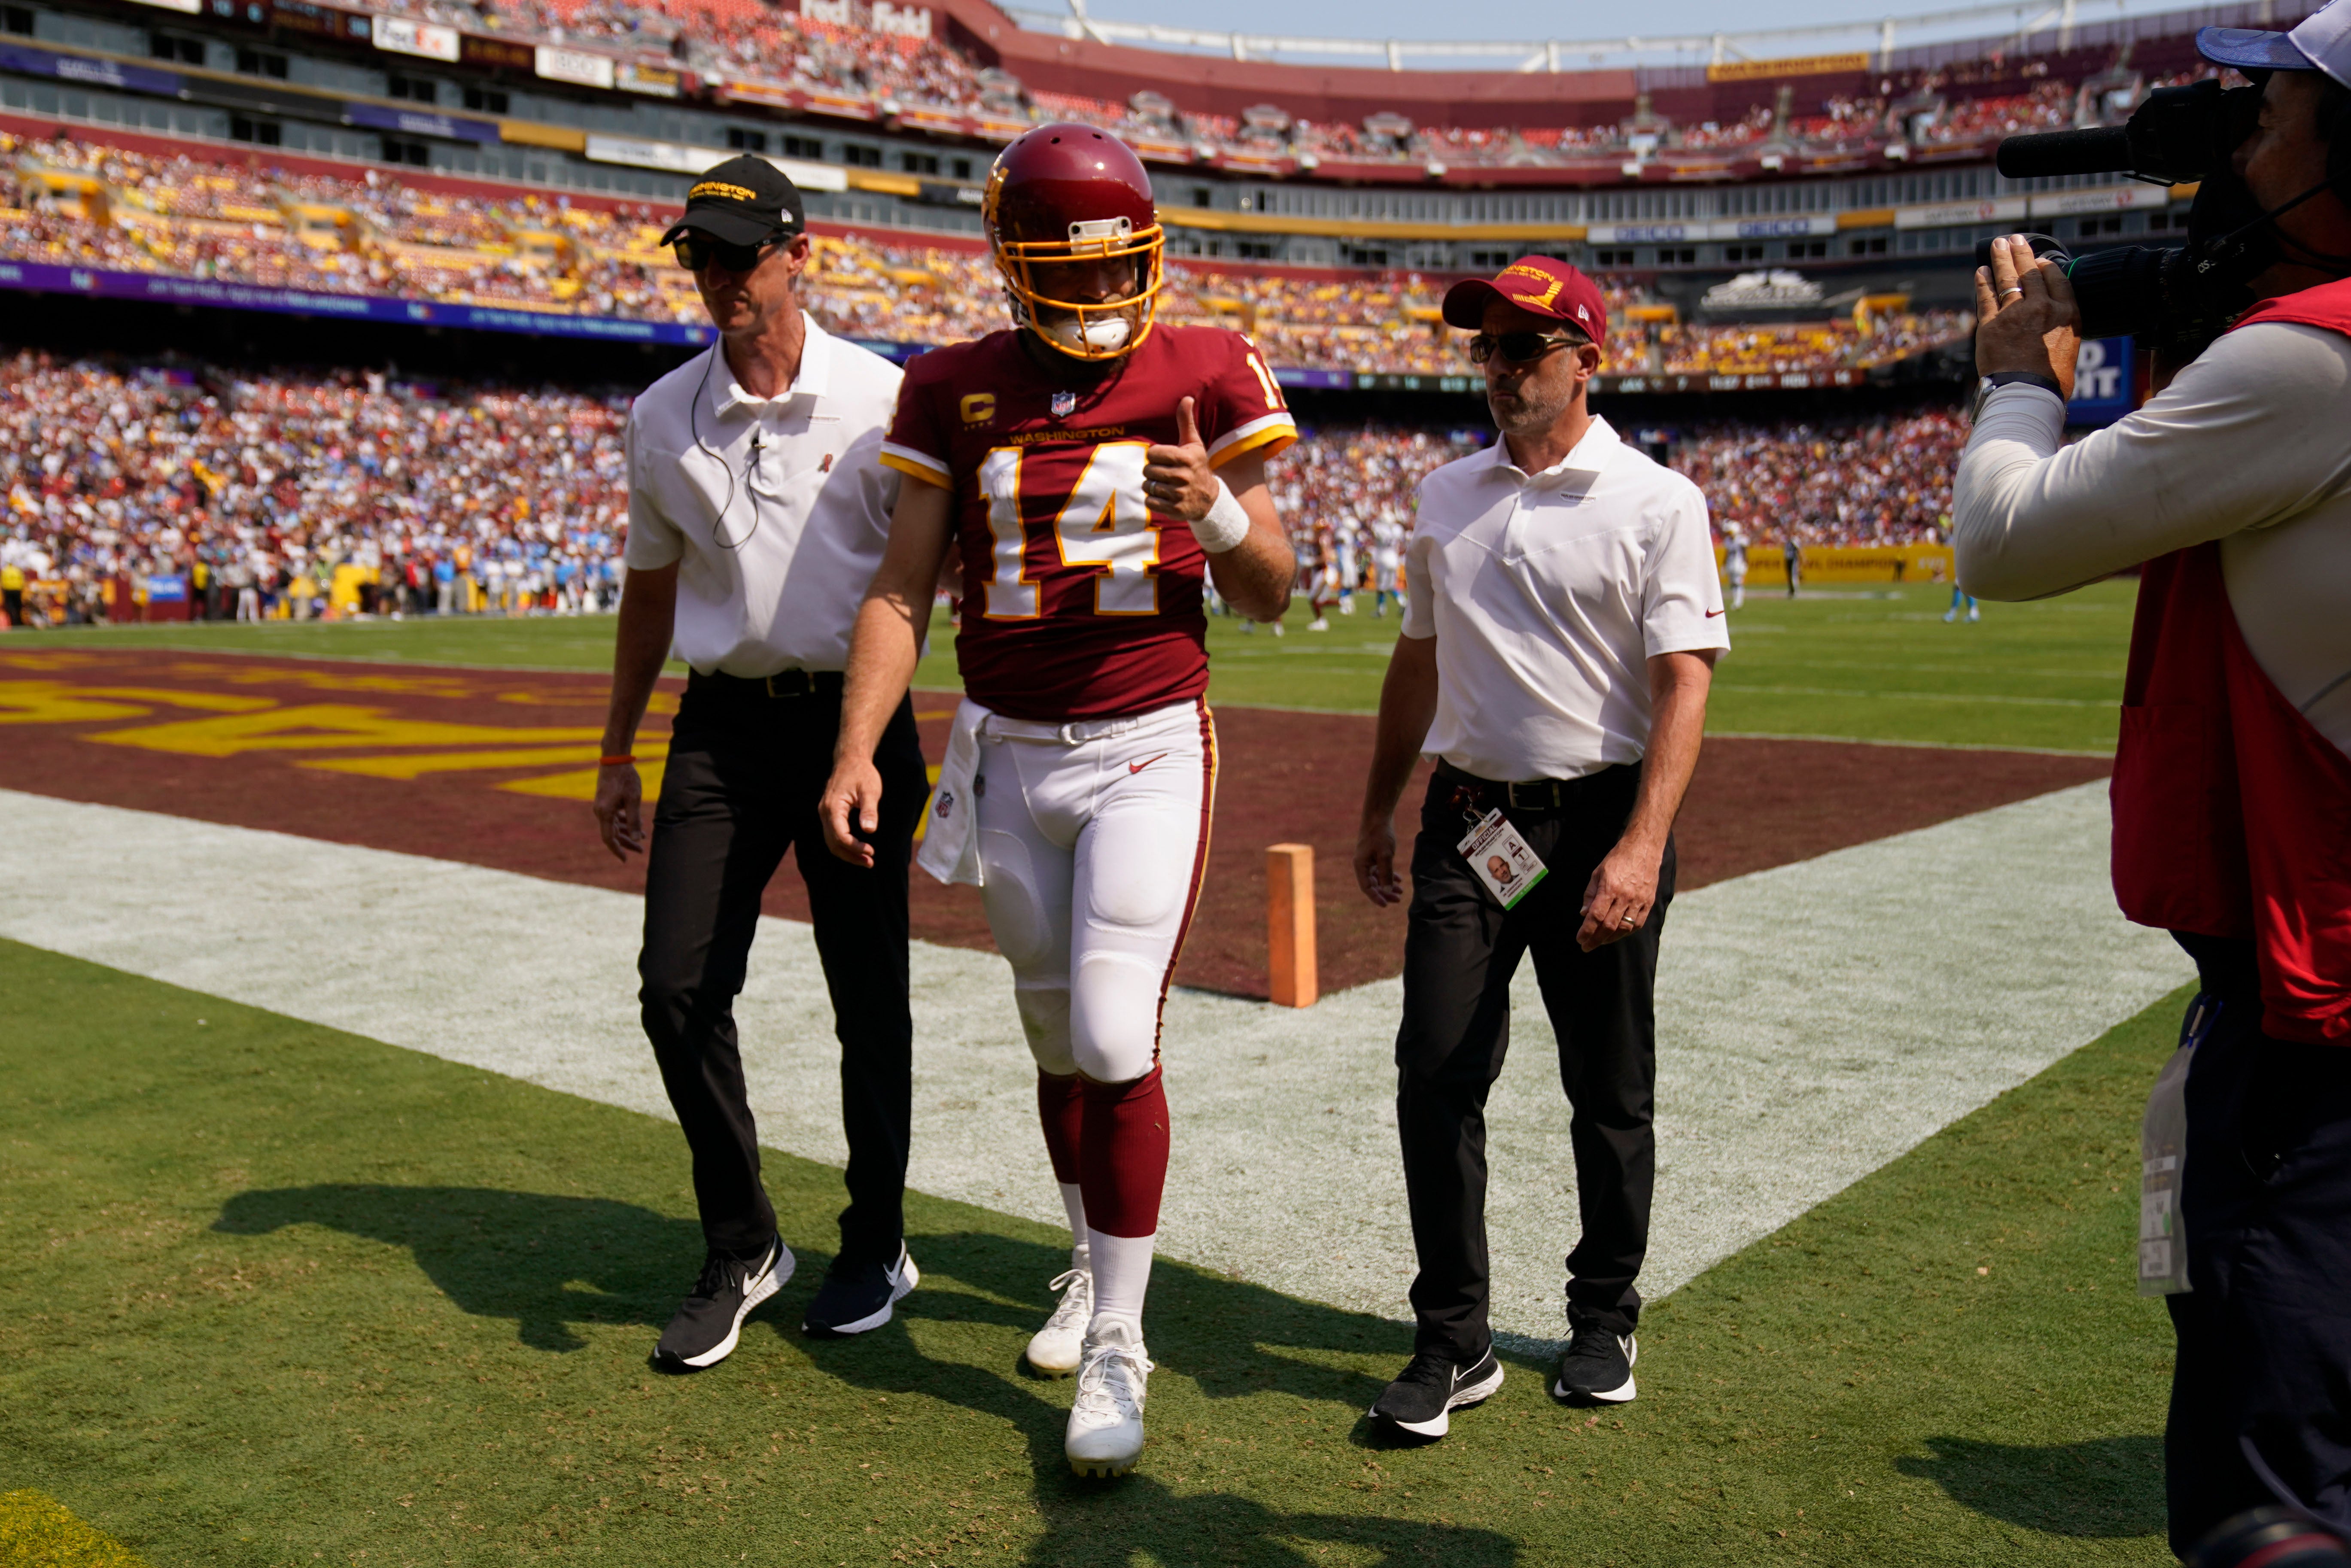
[{"xmin": 7, "ymin": 580, "xmax": 2137, "ymax": 752}]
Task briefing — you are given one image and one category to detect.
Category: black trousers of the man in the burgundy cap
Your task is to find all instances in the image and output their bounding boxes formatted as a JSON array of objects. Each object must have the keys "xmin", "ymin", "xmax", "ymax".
[{"xmin": 1396, "ymin": 766, "xmax": 1674, "ymax": 1361}]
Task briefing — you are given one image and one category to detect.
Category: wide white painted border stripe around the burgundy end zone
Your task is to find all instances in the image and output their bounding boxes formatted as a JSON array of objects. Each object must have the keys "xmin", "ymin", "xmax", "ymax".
[{"xmin": 0, "ymin": 785, "xmax": 2191, "ymax": 1340}]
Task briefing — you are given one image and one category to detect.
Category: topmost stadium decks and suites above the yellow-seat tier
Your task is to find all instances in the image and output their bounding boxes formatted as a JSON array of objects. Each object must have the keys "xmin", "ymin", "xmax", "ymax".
[{"xmin": 0, "ymin": 0, "xmax": 2302, "ymax": 227}]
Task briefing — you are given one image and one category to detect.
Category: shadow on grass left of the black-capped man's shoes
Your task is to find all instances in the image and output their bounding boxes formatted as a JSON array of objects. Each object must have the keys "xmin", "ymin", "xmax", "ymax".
[{"xmin": 212, "ymin": 1182, "xmax": 703, "ymax": 1349}]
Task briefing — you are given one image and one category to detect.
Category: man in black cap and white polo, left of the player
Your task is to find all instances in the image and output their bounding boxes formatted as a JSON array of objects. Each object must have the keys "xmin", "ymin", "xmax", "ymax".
[{"xmin": 595, "ymin": 158, "xmax": 929, "ymax": 1370}]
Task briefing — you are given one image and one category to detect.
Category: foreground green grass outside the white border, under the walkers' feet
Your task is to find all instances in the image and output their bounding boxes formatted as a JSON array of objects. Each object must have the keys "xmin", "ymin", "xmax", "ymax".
[{"xmin": 0, "ymin": 943, "xmax": 2179, "ymax": 1568}]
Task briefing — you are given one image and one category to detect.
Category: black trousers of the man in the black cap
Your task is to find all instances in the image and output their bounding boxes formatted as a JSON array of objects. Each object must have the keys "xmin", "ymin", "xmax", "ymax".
[{"xmin": 637, "ymin": 677, "xmax": 931, "ymax": 1260}]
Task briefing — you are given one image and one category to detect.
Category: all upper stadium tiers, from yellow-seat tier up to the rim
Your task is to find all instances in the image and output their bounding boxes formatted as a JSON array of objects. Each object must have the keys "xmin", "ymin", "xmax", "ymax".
[{"xmin": 0, "ymin": 0, "xmax": 2299, "ymax": 386}]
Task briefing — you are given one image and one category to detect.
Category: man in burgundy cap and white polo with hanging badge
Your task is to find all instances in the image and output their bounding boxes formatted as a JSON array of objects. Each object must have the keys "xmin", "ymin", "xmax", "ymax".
[{"xmin": 1354, "ymin": 256, "xmax": 1731, "ymax": 1439}]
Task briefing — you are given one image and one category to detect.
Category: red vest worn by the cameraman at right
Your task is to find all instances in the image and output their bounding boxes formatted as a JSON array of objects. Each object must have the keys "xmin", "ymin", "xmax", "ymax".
[{"xmin": 2111, "ymin": 280, "xmax": 2351, "ymax": 1046}]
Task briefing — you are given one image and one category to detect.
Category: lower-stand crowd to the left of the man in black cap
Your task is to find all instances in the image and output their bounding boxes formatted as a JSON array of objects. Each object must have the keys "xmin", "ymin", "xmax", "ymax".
[{"xmin": 0, "ymin": 352, "xmax": 628, "ymax": 620}]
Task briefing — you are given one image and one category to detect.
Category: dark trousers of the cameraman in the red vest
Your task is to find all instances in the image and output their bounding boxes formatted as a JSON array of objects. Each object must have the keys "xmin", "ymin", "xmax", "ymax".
[{"xmin": 2163, "ymin": 936, "xmax": 2351, "ymax": 1556}]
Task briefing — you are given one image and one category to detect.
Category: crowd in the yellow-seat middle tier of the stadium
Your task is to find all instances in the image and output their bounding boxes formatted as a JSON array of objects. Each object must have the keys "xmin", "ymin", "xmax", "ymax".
[{"xmin": 0, "ymin": 132, "xmax": 1965, "ymax": 374}]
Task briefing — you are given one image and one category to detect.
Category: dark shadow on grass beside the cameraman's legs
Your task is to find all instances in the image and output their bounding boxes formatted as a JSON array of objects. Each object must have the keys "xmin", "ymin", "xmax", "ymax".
[{"xmin": 1895, "ymin": 1436, "xmax": 2163, "ymax": 1540}]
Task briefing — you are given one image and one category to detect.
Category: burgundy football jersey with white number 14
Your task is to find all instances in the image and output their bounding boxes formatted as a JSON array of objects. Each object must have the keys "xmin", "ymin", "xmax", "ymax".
[{"xmin": 882, "ymin": 327, "xmax": 1298, "ymax": 719}]
